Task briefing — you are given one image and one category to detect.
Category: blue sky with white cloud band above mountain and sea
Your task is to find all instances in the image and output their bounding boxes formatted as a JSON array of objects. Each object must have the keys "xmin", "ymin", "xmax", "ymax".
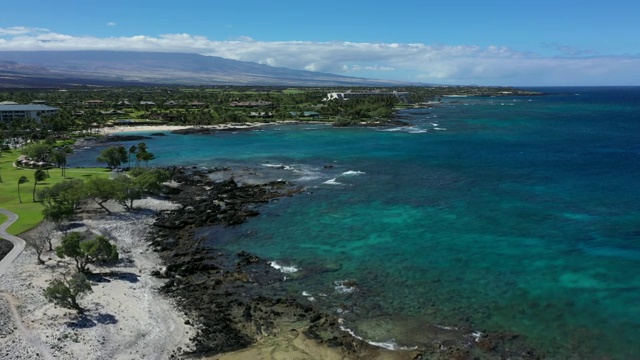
[{"xmin": 0, "ymin": 0, "xmax": 640, "ymax": 86}]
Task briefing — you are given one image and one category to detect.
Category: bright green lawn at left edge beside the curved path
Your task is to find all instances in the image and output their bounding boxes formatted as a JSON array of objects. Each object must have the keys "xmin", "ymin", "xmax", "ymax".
[{"xmin": 0, "ymin": 150, "xmax": 109, "ymax": 235}]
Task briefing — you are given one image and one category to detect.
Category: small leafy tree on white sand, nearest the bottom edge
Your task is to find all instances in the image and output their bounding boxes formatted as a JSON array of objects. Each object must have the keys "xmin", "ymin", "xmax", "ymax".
[{"xmin": 44, "ymin": 272, "xmax": 93, "ymax": 314}]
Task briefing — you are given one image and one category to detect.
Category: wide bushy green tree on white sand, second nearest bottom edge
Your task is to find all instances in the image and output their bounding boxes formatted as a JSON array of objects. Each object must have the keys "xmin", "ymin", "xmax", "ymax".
[{"xmin": 56, "ymin": 231, "xmax": 119, "ymax": 273}]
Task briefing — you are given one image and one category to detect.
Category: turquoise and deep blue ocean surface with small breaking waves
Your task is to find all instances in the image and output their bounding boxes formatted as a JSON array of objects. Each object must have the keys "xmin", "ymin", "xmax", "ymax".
[{"xmin": 69, "ymin": 87, "xmax": 640, "ymax": 359}]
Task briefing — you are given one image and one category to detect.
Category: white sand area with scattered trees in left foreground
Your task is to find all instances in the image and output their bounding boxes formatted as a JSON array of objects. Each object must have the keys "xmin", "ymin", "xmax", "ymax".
[{"xmin": 0, "ymin": 199, "xmax": 196, "ymax": 360}]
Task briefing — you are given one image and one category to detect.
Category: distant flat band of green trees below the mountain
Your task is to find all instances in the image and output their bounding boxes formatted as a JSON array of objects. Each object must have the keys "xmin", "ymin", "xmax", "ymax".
[{"xmin": 0, "ymin": 86, "xmax": 534, "ymax": 131}]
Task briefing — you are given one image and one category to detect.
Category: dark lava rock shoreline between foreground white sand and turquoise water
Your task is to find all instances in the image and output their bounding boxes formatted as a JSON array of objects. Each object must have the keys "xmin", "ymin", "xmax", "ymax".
[{"xmin": 148, "ymin": 168, "xmax": 539, "ymax": 359}]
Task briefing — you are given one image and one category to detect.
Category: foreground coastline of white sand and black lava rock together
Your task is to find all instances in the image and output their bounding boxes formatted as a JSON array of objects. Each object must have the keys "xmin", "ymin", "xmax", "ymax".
[{"xmin": 0, "ymin": 140, "xmax": 536, "ymax": 360}]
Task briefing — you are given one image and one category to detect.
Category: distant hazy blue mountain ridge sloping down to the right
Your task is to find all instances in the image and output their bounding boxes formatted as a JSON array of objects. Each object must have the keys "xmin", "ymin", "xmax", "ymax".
[{"xmin": 0, "ymin": 51, "xmax": 416, "ymax": 87}]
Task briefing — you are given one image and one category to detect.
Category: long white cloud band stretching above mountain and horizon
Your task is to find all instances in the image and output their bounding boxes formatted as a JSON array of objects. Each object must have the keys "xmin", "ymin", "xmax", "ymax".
[{"xmin": 0, "ymin": 27, "xmax": 640, "ymax": 85}]
